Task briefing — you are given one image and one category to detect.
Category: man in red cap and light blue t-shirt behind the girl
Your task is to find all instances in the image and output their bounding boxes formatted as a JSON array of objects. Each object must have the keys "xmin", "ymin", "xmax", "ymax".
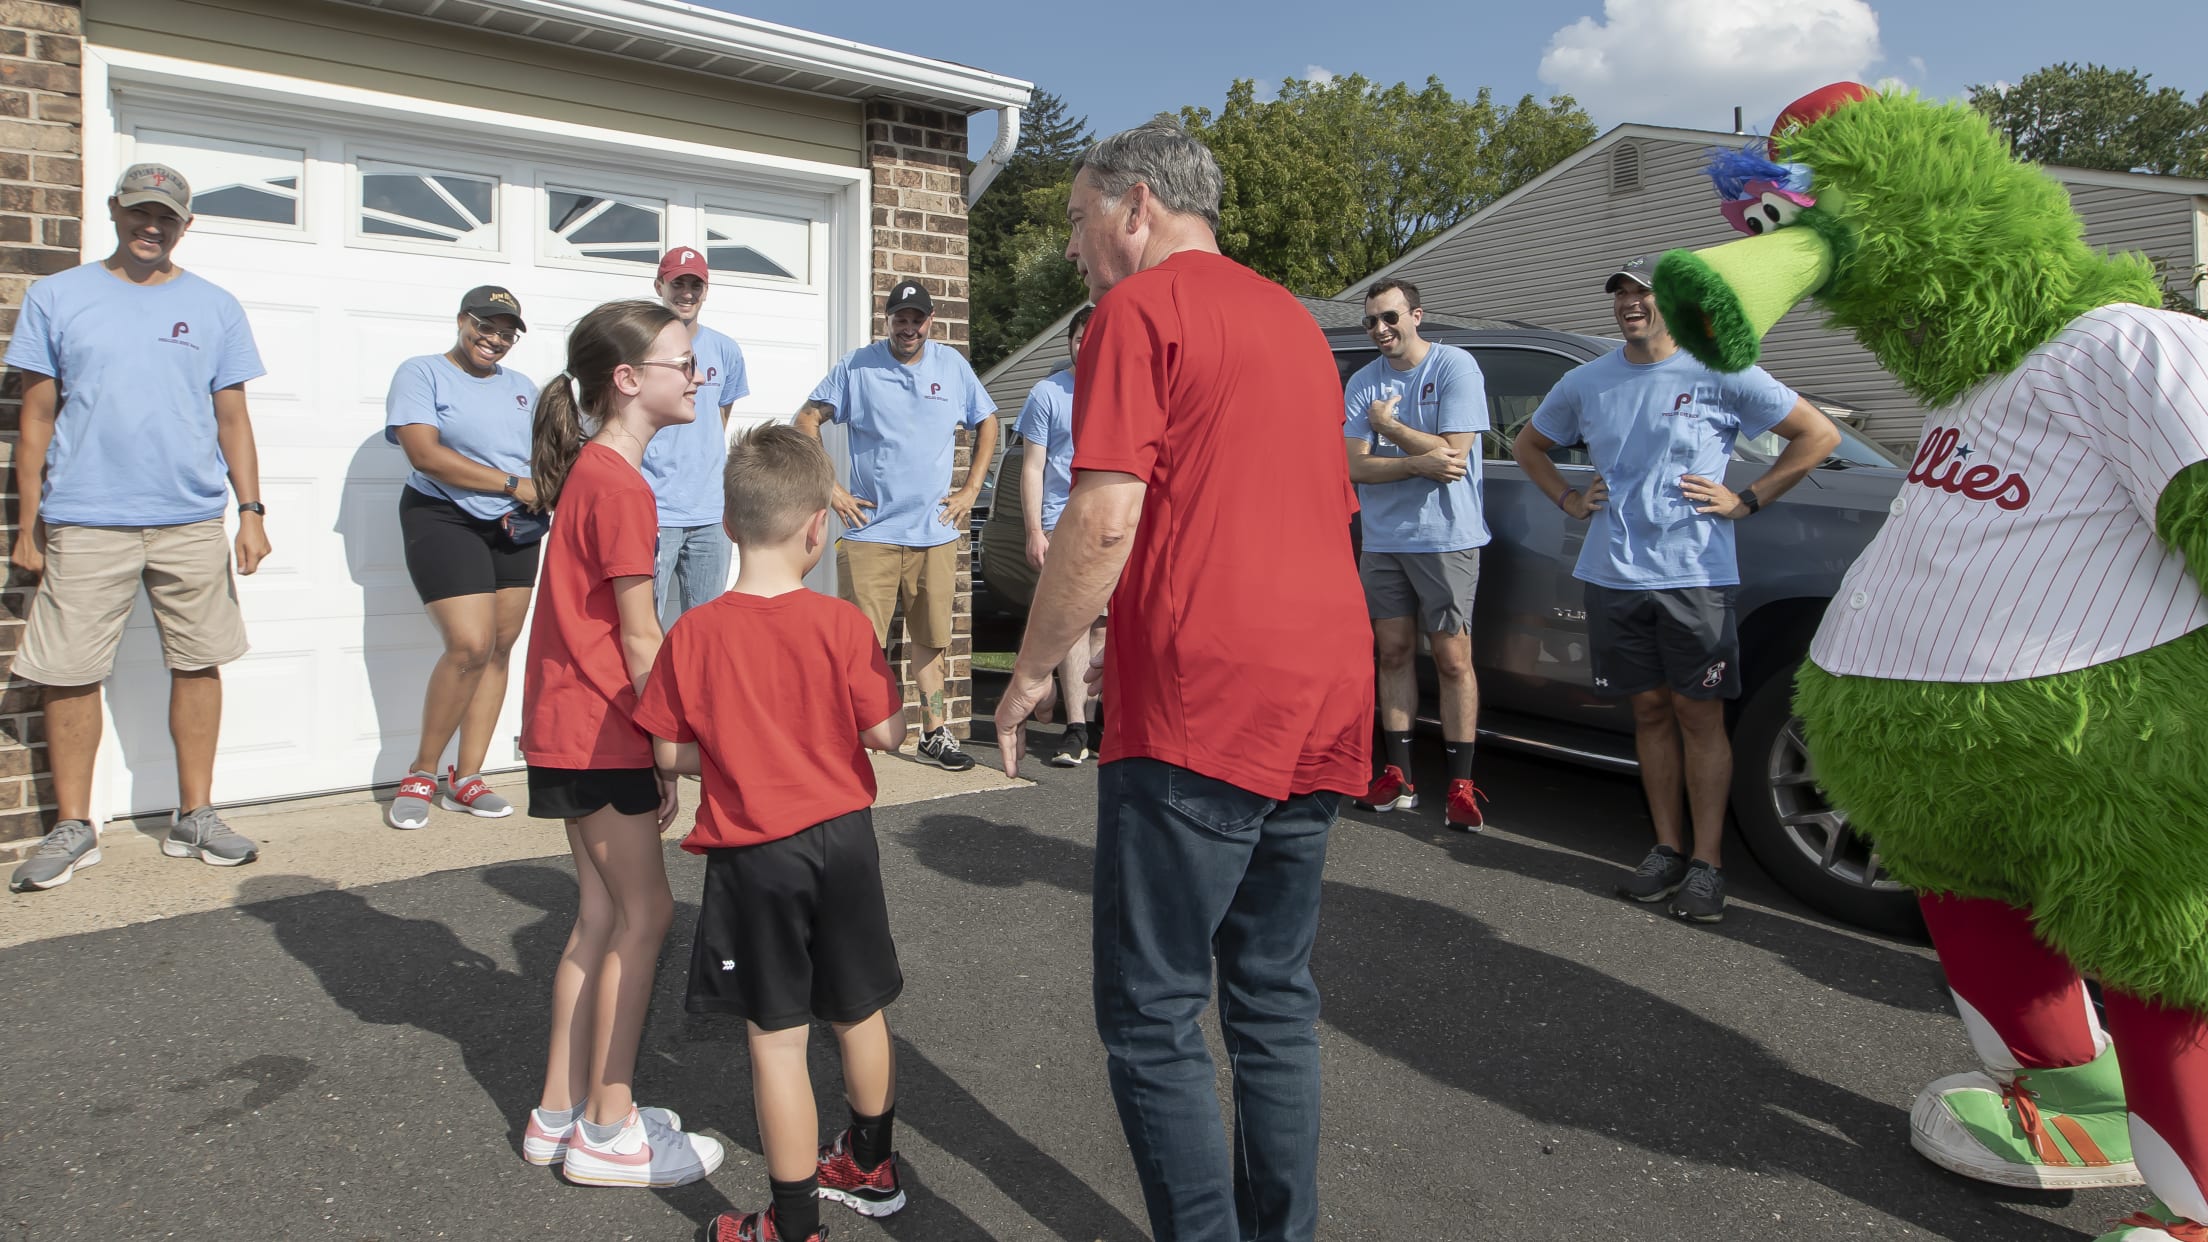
[{"xmin": 645, "ymin": 245, "xmax": 751, "ymax": 625}]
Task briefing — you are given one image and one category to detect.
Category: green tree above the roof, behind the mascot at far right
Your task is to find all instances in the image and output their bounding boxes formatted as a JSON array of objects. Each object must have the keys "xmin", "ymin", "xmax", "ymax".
[{"xmin": 1970, "ymin": 64, "xmax": 2208, "ymax": 177}]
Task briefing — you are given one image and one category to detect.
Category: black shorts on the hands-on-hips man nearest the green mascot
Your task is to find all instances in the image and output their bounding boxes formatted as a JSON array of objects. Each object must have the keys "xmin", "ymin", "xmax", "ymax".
[{"xmin": 1583, "ymin": 581, "xmax": 1740, "ymax": 698}]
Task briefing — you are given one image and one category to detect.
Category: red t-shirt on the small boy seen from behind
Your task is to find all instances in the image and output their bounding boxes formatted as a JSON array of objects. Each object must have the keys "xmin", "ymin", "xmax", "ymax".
[{"xmin": 636, "ymin": 590, "xmax": 905, "ymax": 853}]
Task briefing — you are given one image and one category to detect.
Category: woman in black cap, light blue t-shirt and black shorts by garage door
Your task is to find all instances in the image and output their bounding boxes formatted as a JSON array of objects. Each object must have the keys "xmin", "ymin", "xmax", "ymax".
[{"xmin": 384, "ymin": 285, "xmax": 545, "ymax": 829}]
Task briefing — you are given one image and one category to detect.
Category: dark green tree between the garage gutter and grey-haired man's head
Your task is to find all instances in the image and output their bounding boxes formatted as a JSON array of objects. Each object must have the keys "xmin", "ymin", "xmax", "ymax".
[{"xmin": 967, "ymin": 91, "xmax": 1095, "ymax": 371}]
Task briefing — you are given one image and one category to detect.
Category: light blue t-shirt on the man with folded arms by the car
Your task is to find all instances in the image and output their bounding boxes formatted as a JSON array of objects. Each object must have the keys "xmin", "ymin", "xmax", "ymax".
[{"xmin": 1342, "ymin": 345, "xmax": 1488, "ymax": 552}]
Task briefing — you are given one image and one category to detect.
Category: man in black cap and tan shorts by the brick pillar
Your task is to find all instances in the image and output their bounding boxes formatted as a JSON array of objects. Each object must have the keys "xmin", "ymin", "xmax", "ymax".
[{"xmin": 797, "ymin": 281, "xmax": 996, "ymax": 771}]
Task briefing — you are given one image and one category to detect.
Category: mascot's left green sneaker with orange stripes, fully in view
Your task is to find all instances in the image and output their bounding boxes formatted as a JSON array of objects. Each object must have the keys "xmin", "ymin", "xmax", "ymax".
[{"xmin": 1910, "ymin": 1048, "xmax": 2146, "ymax": 1184}]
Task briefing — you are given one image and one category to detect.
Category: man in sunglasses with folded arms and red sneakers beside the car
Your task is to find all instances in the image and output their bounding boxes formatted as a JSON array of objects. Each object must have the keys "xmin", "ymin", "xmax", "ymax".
[{"xmin": 1342, "ymin": 278, "xmax": 1488, "ymax": 833}]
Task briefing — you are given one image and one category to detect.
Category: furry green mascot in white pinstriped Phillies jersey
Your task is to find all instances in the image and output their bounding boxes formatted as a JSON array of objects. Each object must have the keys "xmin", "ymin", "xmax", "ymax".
[{"xmin": 1656, "ymin": 84, "xmax": 2208, "ymax": 1242}]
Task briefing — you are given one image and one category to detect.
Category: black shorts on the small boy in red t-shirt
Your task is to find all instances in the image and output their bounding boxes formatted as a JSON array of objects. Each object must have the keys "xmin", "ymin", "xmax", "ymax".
[{"xmin": 682, "ymin": 811, "xmax": 905, "ymax": 1030}]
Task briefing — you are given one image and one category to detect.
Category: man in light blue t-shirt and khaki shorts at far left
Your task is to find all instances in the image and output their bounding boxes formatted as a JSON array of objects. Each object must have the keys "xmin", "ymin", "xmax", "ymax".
[{"xmin": 7, "ymin": 164, "xmax": 269, "ymax": 891}]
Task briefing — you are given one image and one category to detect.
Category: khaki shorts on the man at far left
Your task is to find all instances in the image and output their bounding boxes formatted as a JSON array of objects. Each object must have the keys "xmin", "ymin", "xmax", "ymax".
[{"xmin": 15, "ymin": 517, "xmax": 245, "ymax": 685}]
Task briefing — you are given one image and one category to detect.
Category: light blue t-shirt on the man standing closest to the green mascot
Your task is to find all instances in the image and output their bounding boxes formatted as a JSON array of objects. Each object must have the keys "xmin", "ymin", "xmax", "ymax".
[{"xmin": 1532, "ymin": 347, "xmax": 1797, "ymax": 590}]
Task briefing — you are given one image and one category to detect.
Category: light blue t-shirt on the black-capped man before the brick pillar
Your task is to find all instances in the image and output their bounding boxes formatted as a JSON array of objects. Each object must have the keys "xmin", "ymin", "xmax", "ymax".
[{"xmin": 808, "ymin": 340, "xmax": 996, "ymax": 548}]
